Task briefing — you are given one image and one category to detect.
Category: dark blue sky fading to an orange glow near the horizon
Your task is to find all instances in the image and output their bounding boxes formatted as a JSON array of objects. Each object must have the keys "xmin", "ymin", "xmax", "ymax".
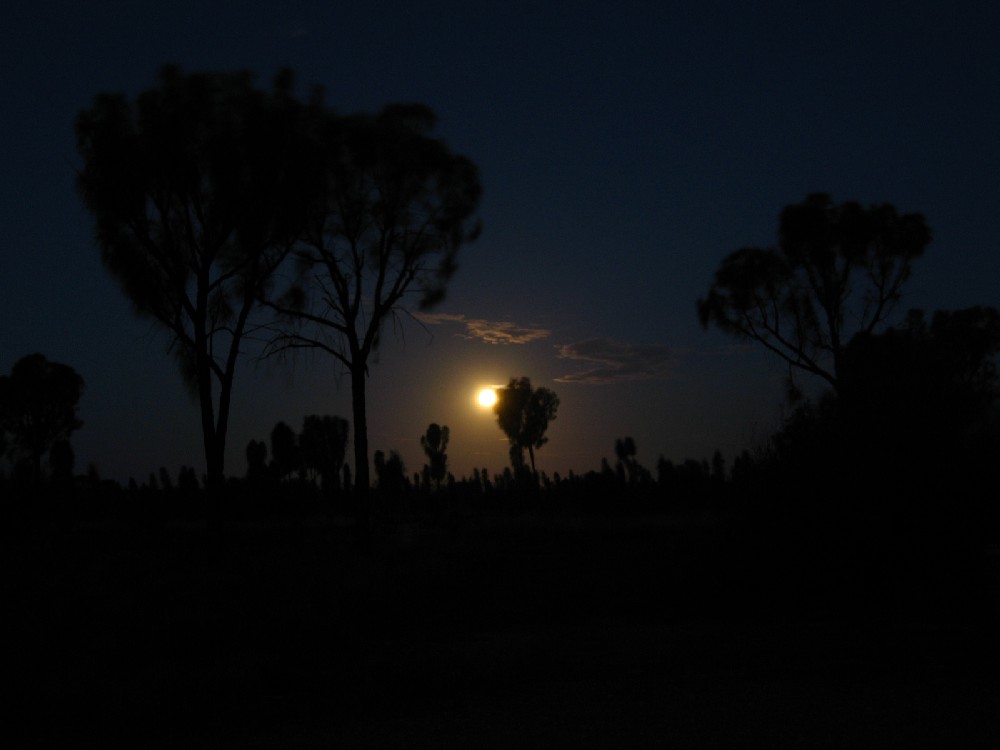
[{"xmin": 0, "ymin": 0, "xmax": 1000, "ymax": 481}]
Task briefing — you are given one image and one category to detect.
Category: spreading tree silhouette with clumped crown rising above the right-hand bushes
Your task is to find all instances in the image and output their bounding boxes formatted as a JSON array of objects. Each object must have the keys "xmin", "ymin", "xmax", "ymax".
[{"xmin": 698, "ymin": 193, "xmax": 931, "ymax": 390}]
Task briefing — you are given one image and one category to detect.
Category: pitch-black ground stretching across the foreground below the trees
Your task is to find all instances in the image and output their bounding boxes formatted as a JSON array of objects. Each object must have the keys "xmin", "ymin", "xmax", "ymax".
[{"xmin": 4, "ymin": 514, "xmax": 1000, "ymax": 748}]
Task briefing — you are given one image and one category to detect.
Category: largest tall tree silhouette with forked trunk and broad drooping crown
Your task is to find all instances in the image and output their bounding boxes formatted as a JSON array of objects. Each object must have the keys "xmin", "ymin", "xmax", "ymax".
[{"xmin": 76, "ymin": 66, "xmax": 314, "ymax": 485}]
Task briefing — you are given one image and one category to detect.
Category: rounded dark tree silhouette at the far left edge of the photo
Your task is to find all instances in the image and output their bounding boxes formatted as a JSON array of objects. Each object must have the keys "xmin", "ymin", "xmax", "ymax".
[{"xmin": 0, "ymin": 354, "xmax": 83, "ymax": 482}]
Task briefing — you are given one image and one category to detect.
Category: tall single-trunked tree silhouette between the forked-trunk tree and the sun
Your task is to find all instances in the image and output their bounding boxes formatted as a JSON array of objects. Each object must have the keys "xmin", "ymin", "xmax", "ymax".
[{"xmin": 271, "ymin": 105, "xmax": 481, "ymax": 536}]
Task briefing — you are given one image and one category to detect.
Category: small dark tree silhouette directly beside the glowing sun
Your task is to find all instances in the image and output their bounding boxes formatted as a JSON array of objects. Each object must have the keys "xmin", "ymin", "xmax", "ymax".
[{"xmin": 493, "ymin": 377, "xmax": 559, "ymax": 474}]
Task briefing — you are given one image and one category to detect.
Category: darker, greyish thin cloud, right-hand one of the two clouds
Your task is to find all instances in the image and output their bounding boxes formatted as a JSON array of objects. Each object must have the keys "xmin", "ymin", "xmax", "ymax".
[{"xmin": 556, "ymin": 338, "xmax": 676, "ymax": 385}]
